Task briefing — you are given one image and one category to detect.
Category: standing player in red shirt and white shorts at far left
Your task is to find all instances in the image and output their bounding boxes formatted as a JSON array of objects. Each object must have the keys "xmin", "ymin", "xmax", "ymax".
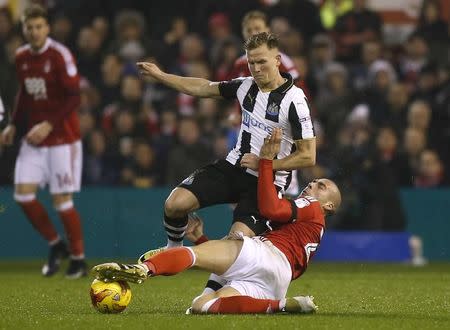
[{"xmin": 2, "ymin": 5, "xmax": 86, "ymax": 278}]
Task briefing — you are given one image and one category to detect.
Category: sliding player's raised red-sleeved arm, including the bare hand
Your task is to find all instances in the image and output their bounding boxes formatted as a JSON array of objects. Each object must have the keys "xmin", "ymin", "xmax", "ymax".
[{"xmin": 258, "ymin": 128, "xmax": 293, "ymax": 222}]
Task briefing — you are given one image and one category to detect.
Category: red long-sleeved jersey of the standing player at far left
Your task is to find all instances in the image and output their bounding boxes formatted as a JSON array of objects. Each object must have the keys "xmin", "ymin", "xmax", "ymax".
[{"xmin": 12, "ymin": 38, "xmax": 80, "ymax": 146}]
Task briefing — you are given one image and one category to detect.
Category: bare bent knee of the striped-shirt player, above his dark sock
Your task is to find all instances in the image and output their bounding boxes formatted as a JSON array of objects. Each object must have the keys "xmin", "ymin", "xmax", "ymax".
[{"xmin": 164, "ymin": 188, "xmax": 198, "ymax": 218}]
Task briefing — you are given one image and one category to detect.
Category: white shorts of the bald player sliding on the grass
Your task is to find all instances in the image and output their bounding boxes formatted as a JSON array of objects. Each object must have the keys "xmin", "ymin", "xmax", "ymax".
[{"xmin": 222, "ymin": 237, "xmax": 292, "ymax": 299}]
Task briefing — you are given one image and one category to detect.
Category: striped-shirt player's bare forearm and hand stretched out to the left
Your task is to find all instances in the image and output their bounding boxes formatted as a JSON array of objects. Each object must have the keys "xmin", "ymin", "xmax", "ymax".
[{"xmin": 136, "ymin": 62, "xmax": 221, "ymax": 98}]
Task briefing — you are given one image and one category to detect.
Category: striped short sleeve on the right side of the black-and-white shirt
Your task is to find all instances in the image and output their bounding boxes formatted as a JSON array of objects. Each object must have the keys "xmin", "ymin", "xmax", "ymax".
[{"xmin": 288, "ymin": 97, "xmax": 315, "ymax": 140}]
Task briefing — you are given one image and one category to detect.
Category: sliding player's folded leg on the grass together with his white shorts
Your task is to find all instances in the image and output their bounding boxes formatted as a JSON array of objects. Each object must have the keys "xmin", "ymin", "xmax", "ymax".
[{"xmin": 192, "ymin": 238, "xmax": 317, "ymax": 314}]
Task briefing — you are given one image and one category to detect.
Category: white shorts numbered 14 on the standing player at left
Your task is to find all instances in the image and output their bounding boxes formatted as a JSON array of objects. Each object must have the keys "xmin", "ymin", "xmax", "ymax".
[{"xmin": 14, "ymin": 140, "xmax": 83, "ymax": 194}]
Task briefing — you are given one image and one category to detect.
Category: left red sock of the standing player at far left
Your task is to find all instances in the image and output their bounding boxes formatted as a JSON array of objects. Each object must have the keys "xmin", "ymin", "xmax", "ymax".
[{"xmin": 19, "ymin": 199, "xmax": 58, "ymax": 242}]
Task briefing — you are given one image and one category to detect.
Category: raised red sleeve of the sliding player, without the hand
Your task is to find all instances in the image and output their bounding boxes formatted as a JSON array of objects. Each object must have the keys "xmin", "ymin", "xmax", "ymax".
[{"xmin": 258, "ymin": 159, "xmax": 297, "ymax": 223}]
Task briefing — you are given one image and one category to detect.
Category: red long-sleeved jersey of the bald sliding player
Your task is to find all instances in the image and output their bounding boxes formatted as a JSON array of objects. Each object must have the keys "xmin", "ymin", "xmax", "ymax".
[{"xmin": 258, "ymin": 160, "xmax": 325, "ymax": 280}]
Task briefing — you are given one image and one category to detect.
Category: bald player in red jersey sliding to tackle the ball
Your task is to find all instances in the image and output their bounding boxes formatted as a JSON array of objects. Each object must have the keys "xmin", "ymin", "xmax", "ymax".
[{"xmin": 92, "ymin": 129, "xmax": 341, "ymax": 314}]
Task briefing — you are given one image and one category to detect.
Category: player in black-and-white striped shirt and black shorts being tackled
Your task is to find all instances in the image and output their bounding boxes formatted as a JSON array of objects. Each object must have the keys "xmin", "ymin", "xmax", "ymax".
[{"xmin": 138, "ymin": 32, "xmax": 316, "ymax": 260}]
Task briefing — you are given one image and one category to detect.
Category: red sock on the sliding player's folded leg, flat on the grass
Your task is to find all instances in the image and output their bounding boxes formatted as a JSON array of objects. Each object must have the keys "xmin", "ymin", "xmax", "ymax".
[{"xmin": 207, "ymin": 296, "xmax": 280, "ymax": 314}]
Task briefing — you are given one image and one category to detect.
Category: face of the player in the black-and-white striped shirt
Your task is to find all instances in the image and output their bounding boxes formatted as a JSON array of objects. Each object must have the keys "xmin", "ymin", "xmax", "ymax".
[{"xmin": 247, "ymin": 45, "xmax": 280, "ymax": 87}]
